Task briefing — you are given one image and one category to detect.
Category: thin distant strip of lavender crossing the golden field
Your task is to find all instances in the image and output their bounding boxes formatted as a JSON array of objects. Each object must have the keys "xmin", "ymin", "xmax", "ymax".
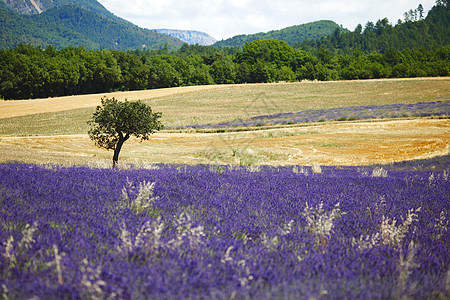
[{"xmin": 182, "ymin": 101, "xmax": 450, "ymax": 128}]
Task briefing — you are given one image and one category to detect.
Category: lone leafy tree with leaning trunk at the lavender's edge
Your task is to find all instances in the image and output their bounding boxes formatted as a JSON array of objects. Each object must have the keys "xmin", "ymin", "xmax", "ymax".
[{"xmin": 88, "ymin": 97, "xmax": 163, "ymax": 168}]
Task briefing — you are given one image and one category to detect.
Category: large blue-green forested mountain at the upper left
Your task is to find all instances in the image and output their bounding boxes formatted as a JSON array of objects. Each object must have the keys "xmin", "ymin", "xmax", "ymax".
[{"xmin": 0, "ymin": 0, "xmax": 183, "ymax": 50}]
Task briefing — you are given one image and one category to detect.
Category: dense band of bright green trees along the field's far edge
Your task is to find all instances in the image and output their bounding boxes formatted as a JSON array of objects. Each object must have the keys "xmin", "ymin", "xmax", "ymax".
[{"xmin": 0, "ymin": 40, "xmax": 450, "ymax": 99}]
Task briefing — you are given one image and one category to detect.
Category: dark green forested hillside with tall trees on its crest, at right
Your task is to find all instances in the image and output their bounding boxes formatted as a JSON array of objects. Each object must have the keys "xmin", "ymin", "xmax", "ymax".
[{"xmin": 298, "ymin": 1, "xmax": 450, "ymax": 54}]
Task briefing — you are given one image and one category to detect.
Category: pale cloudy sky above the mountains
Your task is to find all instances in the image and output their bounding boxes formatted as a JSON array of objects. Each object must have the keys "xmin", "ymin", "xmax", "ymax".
[{"xmin": 98, "ymin": 0, "xmax": 436, "ymax": 40}]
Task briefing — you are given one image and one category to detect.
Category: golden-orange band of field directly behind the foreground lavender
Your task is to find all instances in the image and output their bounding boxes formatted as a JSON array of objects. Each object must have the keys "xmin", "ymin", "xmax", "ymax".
[{"xmin": 0, "ymin": 119, "xmax": 450, "ymax": 166}]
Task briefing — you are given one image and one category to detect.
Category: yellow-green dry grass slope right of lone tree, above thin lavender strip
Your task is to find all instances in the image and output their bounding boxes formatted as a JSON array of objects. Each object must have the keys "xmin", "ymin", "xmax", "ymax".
[{"xmin": 144, "ymin": 78, "xmax": 450, "ymax": 126}]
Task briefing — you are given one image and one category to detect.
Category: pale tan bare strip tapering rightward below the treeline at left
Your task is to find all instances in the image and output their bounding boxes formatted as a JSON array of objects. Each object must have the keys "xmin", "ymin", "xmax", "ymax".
[{"xmin": 0, "ymin": 85, "xmax": 223, "ymax": 118}]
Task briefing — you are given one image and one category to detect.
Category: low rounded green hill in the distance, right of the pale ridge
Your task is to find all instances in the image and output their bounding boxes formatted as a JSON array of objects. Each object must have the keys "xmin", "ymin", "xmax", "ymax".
[{"xmin": 214, "ymin": 21, "xmax": 347, "ymax": 48}]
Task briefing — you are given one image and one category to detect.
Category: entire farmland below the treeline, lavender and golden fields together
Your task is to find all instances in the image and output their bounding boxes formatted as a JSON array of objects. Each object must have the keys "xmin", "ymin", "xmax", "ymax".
[{"xmin": 0, "ymin": 78, "xmax": 450, "ymax": 299}]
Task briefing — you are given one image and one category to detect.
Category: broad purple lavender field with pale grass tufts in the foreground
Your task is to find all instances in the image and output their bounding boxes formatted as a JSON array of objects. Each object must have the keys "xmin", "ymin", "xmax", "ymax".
[{"xmin": 0, "ymin": 164, "xmax": 450, "ymax": 299}]
